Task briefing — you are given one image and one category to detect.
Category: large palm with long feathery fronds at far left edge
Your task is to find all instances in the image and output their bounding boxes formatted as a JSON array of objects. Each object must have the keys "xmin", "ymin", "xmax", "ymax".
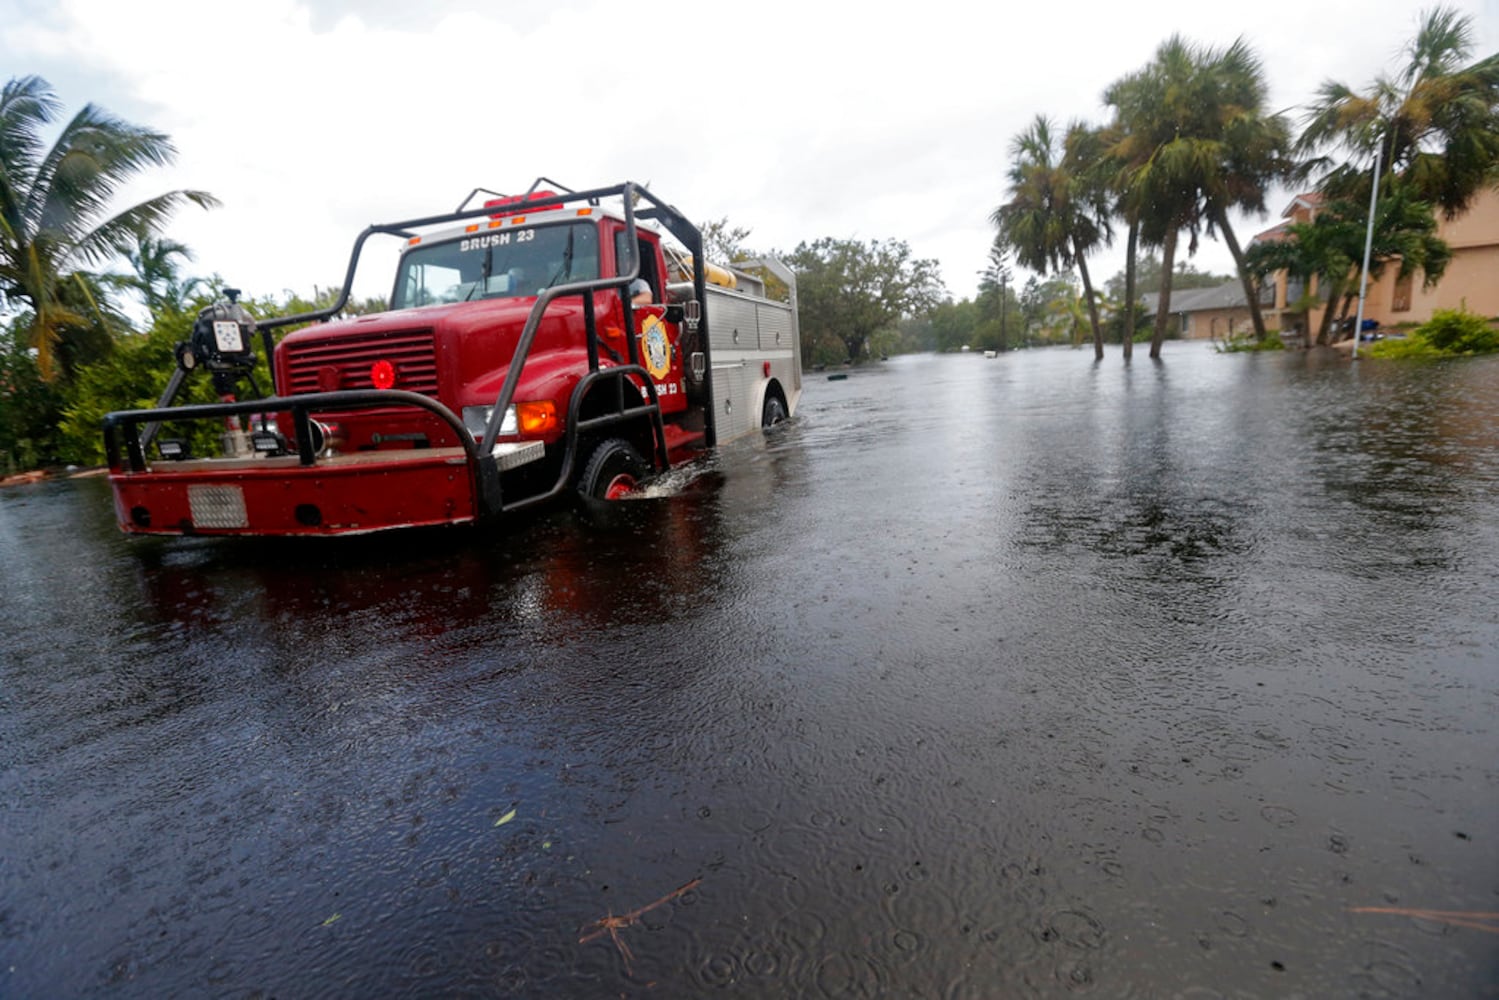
[{"xmin": 0, "ymin": 76, "xmax": 217, "ymax": 379}]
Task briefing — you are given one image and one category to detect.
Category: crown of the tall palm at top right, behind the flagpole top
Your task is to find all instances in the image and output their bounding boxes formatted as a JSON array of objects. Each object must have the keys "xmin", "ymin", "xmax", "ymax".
[{"xmin": 1298, "ymin": 7, "xmax": 1499, "ymax": 219}]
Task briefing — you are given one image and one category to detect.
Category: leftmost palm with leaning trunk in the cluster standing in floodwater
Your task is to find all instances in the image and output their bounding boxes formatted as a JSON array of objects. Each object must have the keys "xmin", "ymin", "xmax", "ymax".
[{"xmin": 989, "ymin": 115, "xmax": 1112, "ymax": 358}]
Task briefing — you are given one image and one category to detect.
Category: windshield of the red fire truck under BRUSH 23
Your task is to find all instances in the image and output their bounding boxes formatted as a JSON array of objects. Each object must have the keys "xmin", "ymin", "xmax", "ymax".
[{"xmin": 391, "ymin": 222, "xmax": 598, "ymax": 309}]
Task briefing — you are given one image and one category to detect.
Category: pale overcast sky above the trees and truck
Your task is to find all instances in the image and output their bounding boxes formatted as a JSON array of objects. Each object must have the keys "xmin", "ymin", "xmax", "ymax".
[{"xmin": 0, "ymin": 0, "xmax": 1499, "ymax": 305}]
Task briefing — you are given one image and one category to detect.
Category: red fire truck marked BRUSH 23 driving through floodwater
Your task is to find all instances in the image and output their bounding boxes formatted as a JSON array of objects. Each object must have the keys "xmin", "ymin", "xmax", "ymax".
[{"xmin": 103, "ymin": 178, "xmax": 802, "ymax": 535}]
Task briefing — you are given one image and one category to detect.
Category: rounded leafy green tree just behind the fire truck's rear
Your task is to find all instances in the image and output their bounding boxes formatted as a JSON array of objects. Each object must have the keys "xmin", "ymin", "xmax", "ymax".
[{"xmin": 785, "ymin": 237, "xmax": 941, "ymax": 361}]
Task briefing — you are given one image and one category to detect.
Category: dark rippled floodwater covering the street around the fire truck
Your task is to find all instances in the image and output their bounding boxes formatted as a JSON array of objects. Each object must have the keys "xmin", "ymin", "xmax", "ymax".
[{"xmin": 0, "ymin": 345, "xmax": 1499, "ymax": 997}]
